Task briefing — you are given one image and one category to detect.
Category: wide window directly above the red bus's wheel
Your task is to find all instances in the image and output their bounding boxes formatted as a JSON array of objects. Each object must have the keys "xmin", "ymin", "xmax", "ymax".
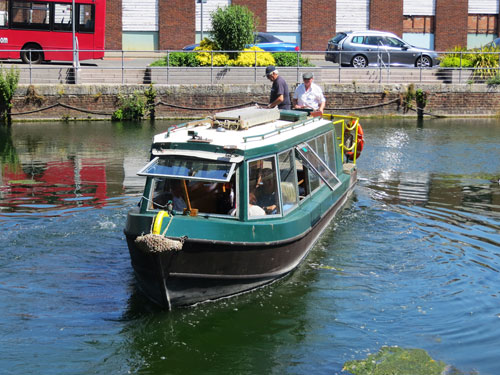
[{"xmin": 12, "ymin": 1, "xmax": 50, "ymax": 30}]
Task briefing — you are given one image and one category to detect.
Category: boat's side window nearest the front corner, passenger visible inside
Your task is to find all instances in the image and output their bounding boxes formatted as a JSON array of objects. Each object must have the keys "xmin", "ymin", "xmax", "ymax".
[{"xmin": 248, "ymin": 156, "xmax": 280, "ymax": 217}]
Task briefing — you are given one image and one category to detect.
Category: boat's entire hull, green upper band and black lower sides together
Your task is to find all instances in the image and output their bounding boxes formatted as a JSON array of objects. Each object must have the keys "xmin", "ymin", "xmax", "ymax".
[{"xmin": 125, "ymin": 169, "xmax": 357, "ymax": 309}]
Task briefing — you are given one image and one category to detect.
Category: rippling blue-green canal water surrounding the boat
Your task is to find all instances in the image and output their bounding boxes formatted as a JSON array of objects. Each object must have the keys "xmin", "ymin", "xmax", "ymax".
[{"xmin": 0, "ymin": 119, "xmax": 500, "ymax": 375}]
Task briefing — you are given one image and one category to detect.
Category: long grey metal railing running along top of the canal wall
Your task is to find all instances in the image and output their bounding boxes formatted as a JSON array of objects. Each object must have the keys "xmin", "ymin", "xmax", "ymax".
[{"xmin": 2, "ymin": 50, "xmax": 500, "ymax": 85}]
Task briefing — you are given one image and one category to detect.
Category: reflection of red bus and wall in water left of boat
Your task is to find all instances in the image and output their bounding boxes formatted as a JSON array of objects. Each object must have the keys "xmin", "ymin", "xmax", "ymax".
[{"xmin": 0, "ymin": 122, "xmax": 177, "ymax": 214}]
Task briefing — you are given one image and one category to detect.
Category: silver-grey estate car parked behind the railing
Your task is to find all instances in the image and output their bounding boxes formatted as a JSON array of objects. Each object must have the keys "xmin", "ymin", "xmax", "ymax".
[{"xmin": 325, "ymin": 30, "xmax": 439, "ymax": 68}]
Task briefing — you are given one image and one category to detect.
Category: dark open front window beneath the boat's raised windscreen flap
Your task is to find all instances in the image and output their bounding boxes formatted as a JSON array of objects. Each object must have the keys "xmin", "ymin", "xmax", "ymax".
[{"xmin": 149, "ymin": 175, "xmax": 237, "ymax": 216}]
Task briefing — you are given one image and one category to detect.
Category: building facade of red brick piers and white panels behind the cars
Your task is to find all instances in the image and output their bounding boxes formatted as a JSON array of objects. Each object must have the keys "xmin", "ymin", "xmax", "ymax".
[{"xmin": 106, "ymin": 0, "xmax": 499, "ymax": 51}]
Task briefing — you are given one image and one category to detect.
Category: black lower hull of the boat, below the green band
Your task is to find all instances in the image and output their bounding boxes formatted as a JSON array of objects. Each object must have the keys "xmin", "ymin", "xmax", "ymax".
[{"xmin": 127, "ymin": 172, "xmax": 356, "ymax": 309}]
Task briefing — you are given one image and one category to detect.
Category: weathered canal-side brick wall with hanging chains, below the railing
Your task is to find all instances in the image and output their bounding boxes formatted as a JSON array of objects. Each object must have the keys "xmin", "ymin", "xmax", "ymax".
[{"xmin": 12, "ymin": 84, "xmax": 500, "ymax": 120}]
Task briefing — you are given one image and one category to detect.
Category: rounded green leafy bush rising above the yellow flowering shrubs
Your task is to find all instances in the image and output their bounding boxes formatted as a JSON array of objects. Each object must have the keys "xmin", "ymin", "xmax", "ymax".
[{"xmin": 211, "ymin": 5, "xmax": 257, "ymax": 59}]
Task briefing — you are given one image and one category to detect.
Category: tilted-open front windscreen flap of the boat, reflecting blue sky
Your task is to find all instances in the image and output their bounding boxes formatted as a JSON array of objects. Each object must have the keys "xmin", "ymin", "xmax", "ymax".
[{"xmin": 137, "ymin": 156, "xmax": 235, "ymax": 182}]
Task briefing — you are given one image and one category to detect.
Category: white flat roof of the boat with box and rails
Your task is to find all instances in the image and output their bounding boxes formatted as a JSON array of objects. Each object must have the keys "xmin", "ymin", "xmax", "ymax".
[{"xmin": 153, "ymin": 107, "xmax": 331, "ymax": 155}]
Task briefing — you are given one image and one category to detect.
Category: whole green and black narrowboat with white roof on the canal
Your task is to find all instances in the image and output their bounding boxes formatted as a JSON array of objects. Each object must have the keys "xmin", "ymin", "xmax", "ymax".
[{"xmin": 124, "ymin": 106, "xmax": 362, "ymax": 309}]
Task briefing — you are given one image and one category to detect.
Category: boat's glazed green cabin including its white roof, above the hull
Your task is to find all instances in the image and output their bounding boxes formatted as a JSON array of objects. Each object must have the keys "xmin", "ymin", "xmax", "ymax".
[{"xmin": 139, "ymin": 107, "xmax": 342, "ymax": 221}]
